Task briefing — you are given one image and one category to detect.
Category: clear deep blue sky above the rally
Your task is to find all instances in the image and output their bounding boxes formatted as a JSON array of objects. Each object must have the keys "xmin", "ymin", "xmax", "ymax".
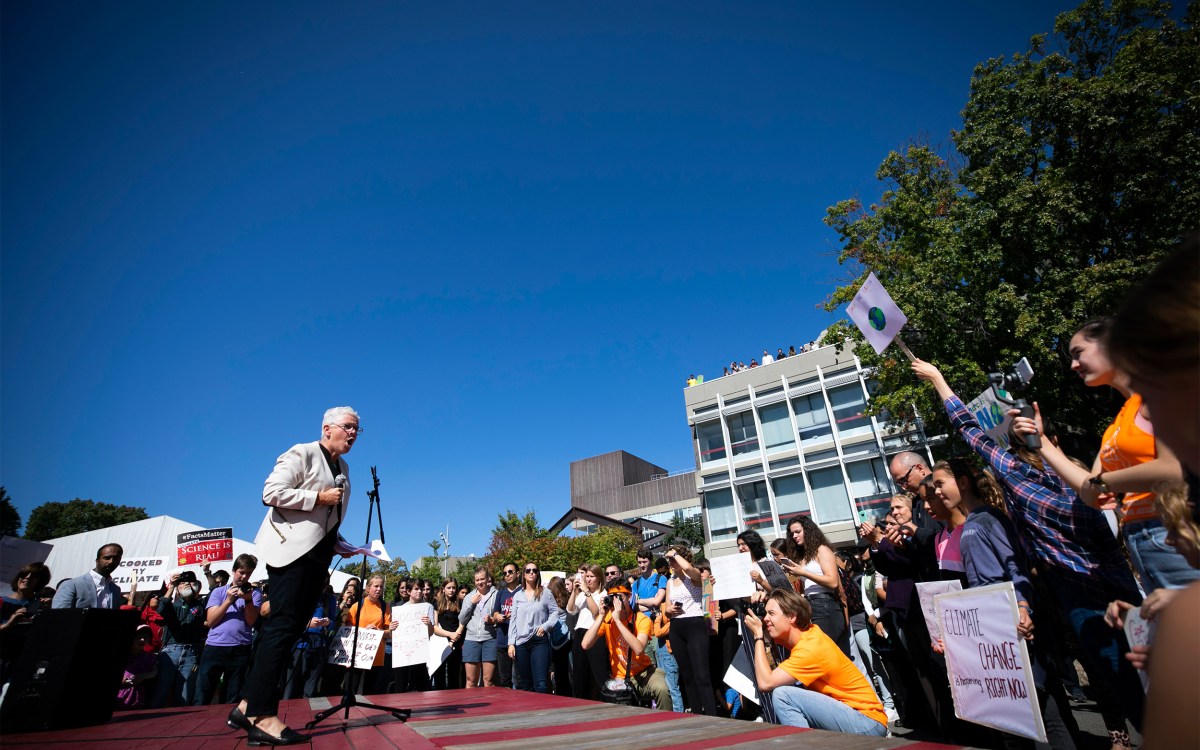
[{"xmin": 0, "ymin": 1, "xmax": 1072, "ymax": 560}]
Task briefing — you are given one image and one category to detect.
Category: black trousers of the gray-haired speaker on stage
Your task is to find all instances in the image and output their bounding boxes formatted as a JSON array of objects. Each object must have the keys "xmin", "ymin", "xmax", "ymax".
[{"xmin": 245, "ymin": 556, "xmax": 329, "ymax": 716}]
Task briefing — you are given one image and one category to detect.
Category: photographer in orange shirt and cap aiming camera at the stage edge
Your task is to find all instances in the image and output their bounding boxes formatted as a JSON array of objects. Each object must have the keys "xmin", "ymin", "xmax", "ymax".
[{"xmin": 583, "ymin": 581, "xmax": 672, "ymax": 710}]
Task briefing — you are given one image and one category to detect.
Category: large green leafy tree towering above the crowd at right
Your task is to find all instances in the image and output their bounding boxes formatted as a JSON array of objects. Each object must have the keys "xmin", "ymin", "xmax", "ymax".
[{"xmin": 826, "ymin": 0, "xmax": 1200, "ymax": 444}]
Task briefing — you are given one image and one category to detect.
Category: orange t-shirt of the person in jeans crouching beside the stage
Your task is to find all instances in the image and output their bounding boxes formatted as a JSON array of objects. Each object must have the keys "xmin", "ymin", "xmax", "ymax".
[{"xmin": 779, "ymin": 625, "xmax": 888, "ymax": 726}]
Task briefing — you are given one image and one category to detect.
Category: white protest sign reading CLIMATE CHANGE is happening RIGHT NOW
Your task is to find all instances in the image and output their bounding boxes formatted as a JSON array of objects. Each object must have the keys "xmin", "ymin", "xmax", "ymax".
[{"xmin": 934, "ymin": 582, "xmax": 1046, "ymax": 742}]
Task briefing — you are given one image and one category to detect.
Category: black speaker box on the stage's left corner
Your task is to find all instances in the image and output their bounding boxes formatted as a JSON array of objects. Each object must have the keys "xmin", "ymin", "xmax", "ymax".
[{"xmin": 0, "ymin": 608, "xmax": 140, "ymax": 733}]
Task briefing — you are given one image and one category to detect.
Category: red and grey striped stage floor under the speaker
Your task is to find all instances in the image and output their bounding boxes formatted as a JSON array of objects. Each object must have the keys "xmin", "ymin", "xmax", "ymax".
[{"xmin": 0, "ymin": 688, "xmax": 946, "ymax": 750}]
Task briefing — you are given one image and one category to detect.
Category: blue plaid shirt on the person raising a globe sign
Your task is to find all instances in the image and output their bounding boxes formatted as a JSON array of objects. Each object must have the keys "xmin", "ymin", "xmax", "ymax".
[{"xmin": 944, "ymin": 396, "xmax": 1140, "ymax": 601}]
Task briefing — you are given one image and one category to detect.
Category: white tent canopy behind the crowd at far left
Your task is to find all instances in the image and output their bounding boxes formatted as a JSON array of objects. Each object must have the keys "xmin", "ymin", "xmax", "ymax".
[{"xmin": 36, "ymin": 516, "xmax": 352, "ymax": 592}]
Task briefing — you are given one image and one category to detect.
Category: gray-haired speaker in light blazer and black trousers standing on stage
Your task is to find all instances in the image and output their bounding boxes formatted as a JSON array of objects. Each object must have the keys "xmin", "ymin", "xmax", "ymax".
[{"xmin": 228, "ymin": 407, "xmax": 362, "ymax": 745}]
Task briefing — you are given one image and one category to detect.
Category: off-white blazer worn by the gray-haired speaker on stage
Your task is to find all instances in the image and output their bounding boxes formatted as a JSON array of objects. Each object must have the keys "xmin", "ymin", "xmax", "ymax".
[{"xmin": 254, "ymin": 443, "xmax": 350, "ymax": 568}]
